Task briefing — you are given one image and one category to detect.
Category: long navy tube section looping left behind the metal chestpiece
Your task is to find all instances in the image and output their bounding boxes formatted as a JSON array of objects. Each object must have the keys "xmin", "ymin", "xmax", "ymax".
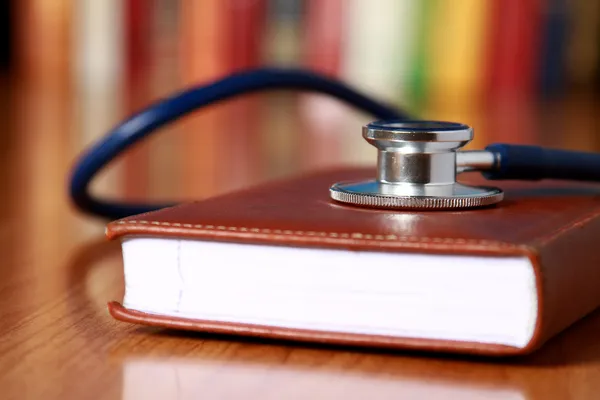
[{"xmin": 70, "ymin": 68, "xmax": 407, "ymax": 219}]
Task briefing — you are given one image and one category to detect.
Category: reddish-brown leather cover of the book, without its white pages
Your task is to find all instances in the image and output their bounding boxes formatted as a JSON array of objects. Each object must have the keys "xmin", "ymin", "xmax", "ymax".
[{"xmin": 106, "ymin": 168, "xmax": 600, "ymax": 356}]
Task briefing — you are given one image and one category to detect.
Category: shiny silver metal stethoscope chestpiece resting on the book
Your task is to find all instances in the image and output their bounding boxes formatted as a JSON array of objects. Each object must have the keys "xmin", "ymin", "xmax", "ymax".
[{"xmin": 330, "ymin": 121, "xmax": 504, "ymax": 210}]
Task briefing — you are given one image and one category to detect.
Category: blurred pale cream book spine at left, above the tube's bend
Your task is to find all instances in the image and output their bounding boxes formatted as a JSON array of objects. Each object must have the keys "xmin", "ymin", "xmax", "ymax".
[{"xmin": 71, "ymin": 0, "xmax": 125, "ymax": 230}]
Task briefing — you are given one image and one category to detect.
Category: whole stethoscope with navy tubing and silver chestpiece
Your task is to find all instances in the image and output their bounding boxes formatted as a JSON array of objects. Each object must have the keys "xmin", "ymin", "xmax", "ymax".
[{"xmin": 70, "ymin": 68, "xmax": 600, "ymax": 219}]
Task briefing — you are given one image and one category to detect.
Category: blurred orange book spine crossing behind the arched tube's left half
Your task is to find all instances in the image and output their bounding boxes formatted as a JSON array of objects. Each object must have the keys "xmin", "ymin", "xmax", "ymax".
[{"xmin": 178, "ymin": 0, "xmax": 228, "ymax": 199}]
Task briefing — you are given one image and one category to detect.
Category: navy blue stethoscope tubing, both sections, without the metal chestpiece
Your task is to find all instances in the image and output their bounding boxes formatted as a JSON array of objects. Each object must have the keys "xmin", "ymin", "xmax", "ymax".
[{"xmin": 70, "ymin": 68, "xmax": 600, "ymax": 219}]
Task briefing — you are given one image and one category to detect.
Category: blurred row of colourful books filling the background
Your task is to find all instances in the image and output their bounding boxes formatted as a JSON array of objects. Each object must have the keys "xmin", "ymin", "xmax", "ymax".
[{"xmin": 3, "ymin": 0, "xmax": 600, "ymax": 205}]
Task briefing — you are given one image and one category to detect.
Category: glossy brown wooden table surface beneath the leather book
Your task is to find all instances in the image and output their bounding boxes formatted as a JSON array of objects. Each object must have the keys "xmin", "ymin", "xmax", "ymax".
[{"xmin": 0, "ymin": 76, "xmax": 600, "ymax": 400}]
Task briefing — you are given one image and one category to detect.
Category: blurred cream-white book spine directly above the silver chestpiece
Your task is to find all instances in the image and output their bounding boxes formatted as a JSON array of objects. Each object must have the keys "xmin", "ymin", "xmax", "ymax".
[{"xmin": 342, "ymin": 0, "xmax": 416, "ymax": 163}]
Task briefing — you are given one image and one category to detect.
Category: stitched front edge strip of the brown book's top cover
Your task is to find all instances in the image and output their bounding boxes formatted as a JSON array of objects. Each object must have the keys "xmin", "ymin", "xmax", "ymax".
[{"xmin": 116, "ymin": 220, "xmax": 527, "ymax": 249}]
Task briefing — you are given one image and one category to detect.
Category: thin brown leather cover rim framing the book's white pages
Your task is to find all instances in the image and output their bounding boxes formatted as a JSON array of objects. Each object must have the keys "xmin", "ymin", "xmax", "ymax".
[{"xmin": 109, "ymin": 228, "xmax": 548, "ymax": 356}]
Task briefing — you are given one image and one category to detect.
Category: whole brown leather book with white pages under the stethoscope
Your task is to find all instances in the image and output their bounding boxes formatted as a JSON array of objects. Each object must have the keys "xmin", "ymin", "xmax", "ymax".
[{"xmin": 107, "ymin": 169, "xmax": 600, "ymax": 356}]
